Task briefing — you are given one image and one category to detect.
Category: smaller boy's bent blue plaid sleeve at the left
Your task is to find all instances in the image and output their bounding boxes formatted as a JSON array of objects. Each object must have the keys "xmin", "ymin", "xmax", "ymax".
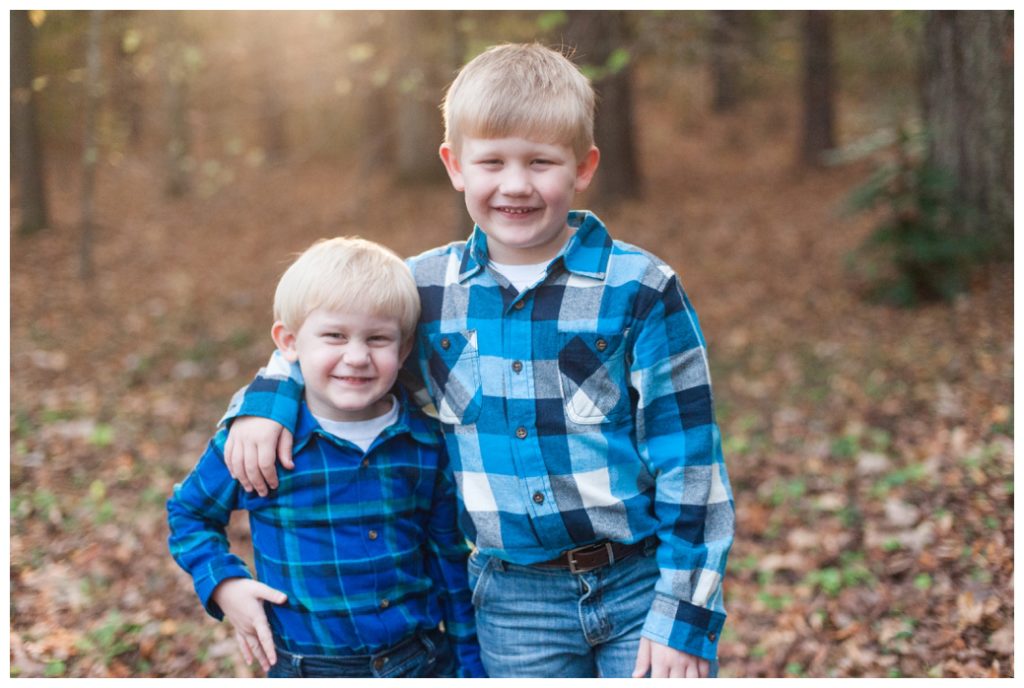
[{"xmin": 167, "ymin": 430, "xmax": 252, "ymax": 620}]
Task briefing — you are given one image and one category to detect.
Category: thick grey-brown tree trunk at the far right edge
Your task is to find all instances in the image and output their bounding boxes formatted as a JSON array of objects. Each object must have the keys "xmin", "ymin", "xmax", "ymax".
[{"xmin": 922, "ymin": 10, "xmax": 1014, "ymax": 249}]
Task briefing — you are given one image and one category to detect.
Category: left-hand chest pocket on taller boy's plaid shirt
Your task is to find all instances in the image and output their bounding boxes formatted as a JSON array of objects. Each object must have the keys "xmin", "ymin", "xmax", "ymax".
[{"xmin": 427, "ymin": 330, "xmax": 483, "ymax": 425}]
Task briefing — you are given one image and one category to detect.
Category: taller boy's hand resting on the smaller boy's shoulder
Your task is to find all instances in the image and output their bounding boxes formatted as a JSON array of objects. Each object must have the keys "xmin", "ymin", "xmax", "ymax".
[{"xmin": 224, "ymin": 416, "xmax": 295, "ymax": 497}]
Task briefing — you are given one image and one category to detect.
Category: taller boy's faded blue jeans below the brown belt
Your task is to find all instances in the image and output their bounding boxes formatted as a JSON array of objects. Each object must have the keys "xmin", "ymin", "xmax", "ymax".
[{"xmin": 469, "ymin": 545, "xmax": 658, "ymax": 678}]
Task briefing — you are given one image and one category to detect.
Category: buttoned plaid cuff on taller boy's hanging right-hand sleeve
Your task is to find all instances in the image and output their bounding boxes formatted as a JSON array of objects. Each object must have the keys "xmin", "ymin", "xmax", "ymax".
[{"xmin": 641, "ymin": 594, "xmax": 725, "ymax": 661}]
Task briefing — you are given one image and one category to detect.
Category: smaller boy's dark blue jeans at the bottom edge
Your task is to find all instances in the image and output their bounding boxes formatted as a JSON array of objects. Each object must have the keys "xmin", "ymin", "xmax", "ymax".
[{"xmin": 267, "ymin": 631, "xmax": 456, "ymax": 679}]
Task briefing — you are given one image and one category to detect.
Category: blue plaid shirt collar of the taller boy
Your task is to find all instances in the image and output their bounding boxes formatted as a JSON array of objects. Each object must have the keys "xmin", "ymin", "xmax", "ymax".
[{"xmin": 459, "ymin": 210, "xmax": 611, "ymax": 282}]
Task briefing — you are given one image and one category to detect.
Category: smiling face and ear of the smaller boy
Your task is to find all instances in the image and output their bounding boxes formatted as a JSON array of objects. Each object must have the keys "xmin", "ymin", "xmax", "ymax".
[{"xmin": 271, "ymin": 308, "xmax": 410, "ymax": 421}]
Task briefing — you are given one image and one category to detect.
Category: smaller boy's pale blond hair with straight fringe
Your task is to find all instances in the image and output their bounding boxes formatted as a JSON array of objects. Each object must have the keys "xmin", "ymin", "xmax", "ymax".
[{"xmin": 273, "ymin": 237, "xmax": 420, "ymax": 341}]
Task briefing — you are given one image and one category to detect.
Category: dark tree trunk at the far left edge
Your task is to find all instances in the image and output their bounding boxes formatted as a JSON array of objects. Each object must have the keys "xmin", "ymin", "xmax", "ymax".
[{"xmin": 10, "ymin": 9, "xmax": 48, "ymax": 234}]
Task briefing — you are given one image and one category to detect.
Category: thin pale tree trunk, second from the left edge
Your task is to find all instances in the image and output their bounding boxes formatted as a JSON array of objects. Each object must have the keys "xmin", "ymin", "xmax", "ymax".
[{"xmin": 79, "ymin": 9, "xmax": 103, "ymax": 280}]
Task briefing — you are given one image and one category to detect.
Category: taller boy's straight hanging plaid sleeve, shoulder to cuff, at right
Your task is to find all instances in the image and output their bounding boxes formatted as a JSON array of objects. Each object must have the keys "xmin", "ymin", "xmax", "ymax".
[{"xmin": 631, "ymin": 271, "xmax": 735, "ymax": 660}]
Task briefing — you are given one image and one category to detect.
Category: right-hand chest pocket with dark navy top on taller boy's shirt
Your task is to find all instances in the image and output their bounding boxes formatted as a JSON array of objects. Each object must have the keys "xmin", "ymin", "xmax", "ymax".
[{"xmin": 558, "ymin": 332, "xmax": 631, "ymax": 425}]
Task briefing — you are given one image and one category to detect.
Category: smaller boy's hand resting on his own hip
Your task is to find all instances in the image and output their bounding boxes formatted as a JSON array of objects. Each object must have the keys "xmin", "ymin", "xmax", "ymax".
[{"xmin": 212, "ymin": 578, "xmax": 288, "ymax": 672}]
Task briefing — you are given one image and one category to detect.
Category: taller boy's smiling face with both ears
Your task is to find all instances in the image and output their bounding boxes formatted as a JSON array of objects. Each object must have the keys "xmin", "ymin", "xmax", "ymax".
[{"xmin": 440, "ymin": 136, "xmax": 600, "ymax": 264}]
